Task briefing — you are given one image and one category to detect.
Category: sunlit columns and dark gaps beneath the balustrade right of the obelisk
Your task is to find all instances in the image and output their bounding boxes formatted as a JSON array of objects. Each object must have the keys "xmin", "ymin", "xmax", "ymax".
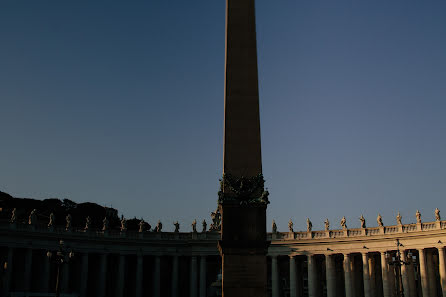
[{"xmin": 271, "ymin": 246, "xmax": 446, "ymax": 297}]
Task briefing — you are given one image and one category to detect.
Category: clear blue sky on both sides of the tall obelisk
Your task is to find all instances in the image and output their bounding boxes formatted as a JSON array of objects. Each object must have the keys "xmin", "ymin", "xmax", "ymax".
[{"xmin": 0, "ymin": 0, "xmax": 446, "ymax": 231}]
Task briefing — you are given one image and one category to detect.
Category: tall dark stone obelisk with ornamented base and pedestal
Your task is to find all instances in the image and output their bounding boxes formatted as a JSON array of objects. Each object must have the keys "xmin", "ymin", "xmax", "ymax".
[{"xmin": 218, "ymin": 0, "xmax": 269, "ymax": 297}]
